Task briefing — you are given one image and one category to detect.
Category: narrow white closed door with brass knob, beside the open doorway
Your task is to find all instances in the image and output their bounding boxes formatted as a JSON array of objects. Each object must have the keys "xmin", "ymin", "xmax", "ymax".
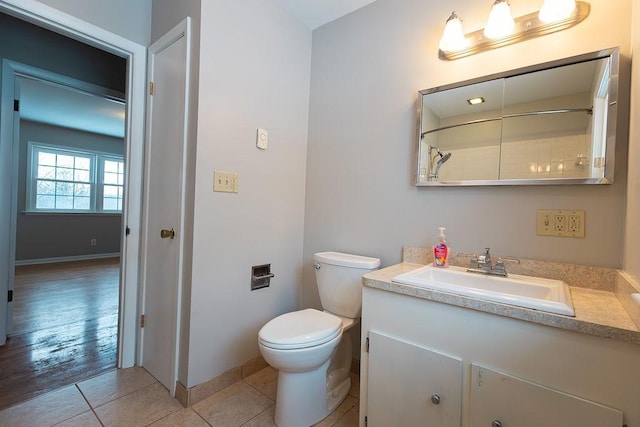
[{"xmin": 141, "ymin": 18, "xmax": 189, "ymax": 394}]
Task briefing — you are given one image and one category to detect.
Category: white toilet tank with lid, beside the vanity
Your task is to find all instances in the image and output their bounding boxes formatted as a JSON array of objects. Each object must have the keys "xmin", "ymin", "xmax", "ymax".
[{"xmin": 313, "ymin": 252, "xmax": 380, "ymax": 319}]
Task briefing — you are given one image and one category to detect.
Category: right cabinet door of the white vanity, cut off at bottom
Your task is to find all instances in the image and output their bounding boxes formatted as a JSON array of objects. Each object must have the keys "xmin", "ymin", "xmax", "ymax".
[{"xmin": 471, "ymin": 364, "xmax": 622, "ymax": 427}]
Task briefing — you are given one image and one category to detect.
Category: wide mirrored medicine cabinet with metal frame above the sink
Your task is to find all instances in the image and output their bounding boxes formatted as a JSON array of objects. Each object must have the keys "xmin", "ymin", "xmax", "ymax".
[{"xmin": 416, "ymin": 48, "xmax": 619, "ymax": 186}]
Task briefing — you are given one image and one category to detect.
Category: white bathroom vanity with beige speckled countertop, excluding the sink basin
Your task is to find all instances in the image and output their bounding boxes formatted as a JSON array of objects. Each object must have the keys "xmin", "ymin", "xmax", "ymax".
[{"xmin": 360, "ymin": 263, "xmax": 640, "ymax": 427}]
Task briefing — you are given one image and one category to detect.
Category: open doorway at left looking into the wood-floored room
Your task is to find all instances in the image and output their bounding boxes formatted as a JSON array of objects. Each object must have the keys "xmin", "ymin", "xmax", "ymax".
[{"xmin": 0, "ymin": 1, "xmax": 144, "ymax": 408}]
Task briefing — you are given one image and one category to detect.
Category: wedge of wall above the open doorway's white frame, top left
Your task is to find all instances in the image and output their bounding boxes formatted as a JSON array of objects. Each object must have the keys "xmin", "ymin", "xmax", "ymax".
[{"xmin": 37, "ymin": 0, "xmax": 151, "ymax": 46}]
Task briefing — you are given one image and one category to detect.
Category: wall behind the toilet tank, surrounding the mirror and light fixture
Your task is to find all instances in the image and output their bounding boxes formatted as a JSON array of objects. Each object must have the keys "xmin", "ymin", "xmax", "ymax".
[{"xmin": 302, "ymin": 0, "xmax": 631, "ymax": 306}]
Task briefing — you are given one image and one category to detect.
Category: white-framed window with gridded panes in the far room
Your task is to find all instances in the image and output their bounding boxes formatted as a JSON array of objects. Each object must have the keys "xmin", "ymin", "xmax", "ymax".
[{"xmin": 27, "ymin": 142, "xmax": 124, "ymax": 213}]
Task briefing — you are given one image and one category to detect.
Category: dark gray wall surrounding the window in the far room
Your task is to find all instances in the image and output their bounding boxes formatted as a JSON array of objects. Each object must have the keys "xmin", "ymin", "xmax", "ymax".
[{"xmin": 16, "ymin": 120, "xmax": 124, "ymax": 262}]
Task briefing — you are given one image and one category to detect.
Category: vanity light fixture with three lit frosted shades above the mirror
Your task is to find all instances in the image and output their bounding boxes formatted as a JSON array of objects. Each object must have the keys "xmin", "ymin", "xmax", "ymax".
[{"xmin": 438, "ymin": 0, "xmax": 591, "ymax": 60}]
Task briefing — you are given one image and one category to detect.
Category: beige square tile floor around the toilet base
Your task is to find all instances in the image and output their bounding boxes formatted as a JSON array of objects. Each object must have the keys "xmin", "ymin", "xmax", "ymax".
[{"xmin": 0, "ymin": 367, "xmax": 360, "ymax": 427}]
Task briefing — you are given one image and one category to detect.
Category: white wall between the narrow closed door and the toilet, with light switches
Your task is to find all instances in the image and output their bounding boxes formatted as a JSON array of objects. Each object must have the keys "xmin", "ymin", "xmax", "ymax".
[{"xmin": 185, "ymin": 0, "xmax": 311, "ymax": 387}]
